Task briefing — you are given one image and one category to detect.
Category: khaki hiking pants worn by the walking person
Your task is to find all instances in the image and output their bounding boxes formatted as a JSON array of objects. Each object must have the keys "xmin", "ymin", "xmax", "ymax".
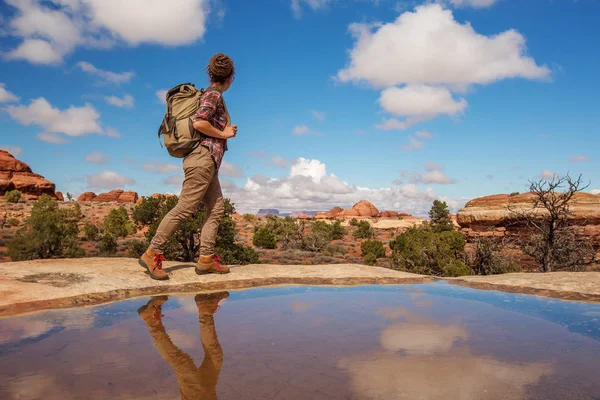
[{"xmin": 150, "ymin": 146, "xmax": 225, "ymax": 256}]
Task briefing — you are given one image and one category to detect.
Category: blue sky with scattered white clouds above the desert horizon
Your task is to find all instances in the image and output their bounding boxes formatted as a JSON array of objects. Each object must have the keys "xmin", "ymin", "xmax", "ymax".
[{"xmin": 0, "ymin": 0, "xmax": 600, "ymax": 215}]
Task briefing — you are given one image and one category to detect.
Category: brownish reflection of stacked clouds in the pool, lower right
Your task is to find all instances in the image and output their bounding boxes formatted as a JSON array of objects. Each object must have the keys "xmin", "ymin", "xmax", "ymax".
[{"xmin": 338, "ymin": 308, "xmax": 553, "ymax": 400}]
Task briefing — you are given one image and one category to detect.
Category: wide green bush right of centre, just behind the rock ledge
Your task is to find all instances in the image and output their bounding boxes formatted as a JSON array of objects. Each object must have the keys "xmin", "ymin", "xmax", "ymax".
[{"xmin": 390, "ymin": 225, "xmax": 470, "ymax": 276}]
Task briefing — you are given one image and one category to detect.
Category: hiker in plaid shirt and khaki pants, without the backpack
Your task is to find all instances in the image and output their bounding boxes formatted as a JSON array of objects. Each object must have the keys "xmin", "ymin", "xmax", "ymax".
[{"xmin": 139, "ymin": 53, "xmax": 237, "ymax": 280}]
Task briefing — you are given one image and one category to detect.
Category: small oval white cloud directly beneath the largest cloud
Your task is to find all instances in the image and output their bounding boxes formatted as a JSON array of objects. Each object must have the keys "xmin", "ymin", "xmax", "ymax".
[{"xmin": 379, "ymin": 85, "xmax": 467, "ymax": 130}]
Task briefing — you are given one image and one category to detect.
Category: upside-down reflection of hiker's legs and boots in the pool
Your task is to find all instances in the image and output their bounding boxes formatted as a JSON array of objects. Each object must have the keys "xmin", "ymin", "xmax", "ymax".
[{"xmin": 138, "ymin": 292, "xmax": 229, "ymax": 400}]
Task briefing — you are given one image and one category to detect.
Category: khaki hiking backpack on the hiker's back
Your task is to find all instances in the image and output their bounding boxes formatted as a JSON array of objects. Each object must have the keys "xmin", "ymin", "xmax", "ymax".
[{"xmin": 158, "ymin": 83, "xmax": 218, "ymax": 158}]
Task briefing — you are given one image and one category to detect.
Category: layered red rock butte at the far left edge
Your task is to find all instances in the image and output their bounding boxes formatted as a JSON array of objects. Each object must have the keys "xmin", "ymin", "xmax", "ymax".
[{"xmin": 0, "ymin": 150, "xmax": 58, "ymax": 200}]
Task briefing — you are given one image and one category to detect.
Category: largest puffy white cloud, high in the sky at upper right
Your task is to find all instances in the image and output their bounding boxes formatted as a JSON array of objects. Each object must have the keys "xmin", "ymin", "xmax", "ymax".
[{"xmin": 337, "ymin": 4, "xmax": 550, "ymax": 87}]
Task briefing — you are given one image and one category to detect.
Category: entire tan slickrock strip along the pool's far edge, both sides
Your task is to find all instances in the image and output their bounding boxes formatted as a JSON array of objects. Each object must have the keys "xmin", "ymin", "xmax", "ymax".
[{"xmin": 0, "ymin": 258, "xmax": 600, "ymax": 317}]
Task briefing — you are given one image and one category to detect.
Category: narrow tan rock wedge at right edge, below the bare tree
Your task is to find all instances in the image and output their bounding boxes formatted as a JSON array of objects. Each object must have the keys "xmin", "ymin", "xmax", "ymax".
[{"xmin": 446, "ymin": 272, "xmax": 600, "ymax": 303}]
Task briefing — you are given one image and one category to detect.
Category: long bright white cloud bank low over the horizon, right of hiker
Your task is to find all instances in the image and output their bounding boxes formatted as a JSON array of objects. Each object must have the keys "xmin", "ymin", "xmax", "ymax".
[{"xmin": 223, "ymin": 158, "xmax": 466, "ymax": 216}]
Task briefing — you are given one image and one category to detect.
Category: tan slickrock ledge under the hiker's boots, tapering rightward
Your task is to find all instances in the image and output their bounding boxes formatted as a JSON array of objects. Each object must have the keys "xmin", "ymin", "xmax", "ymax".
[{"xmin": 0, "ymin": 258, "xmax": 435, "ymax": 317}]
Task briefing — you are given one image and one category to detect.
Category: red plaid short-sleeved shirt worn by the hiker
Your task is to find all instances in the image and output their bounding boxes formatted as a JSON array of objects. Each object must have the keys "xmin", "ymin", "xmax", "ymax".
[{"xmin": 192, "ymin": 90, "xmax": 231, "ymax": 171}]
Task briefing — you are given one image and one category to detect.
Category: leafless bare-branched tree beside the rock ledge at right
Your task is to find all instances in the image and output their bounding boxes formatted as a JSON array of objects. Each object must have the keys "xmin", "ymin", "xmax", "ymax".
[{"xmin": 508, "ymin": 174, "xmax": 594, "ymax": 272}]
